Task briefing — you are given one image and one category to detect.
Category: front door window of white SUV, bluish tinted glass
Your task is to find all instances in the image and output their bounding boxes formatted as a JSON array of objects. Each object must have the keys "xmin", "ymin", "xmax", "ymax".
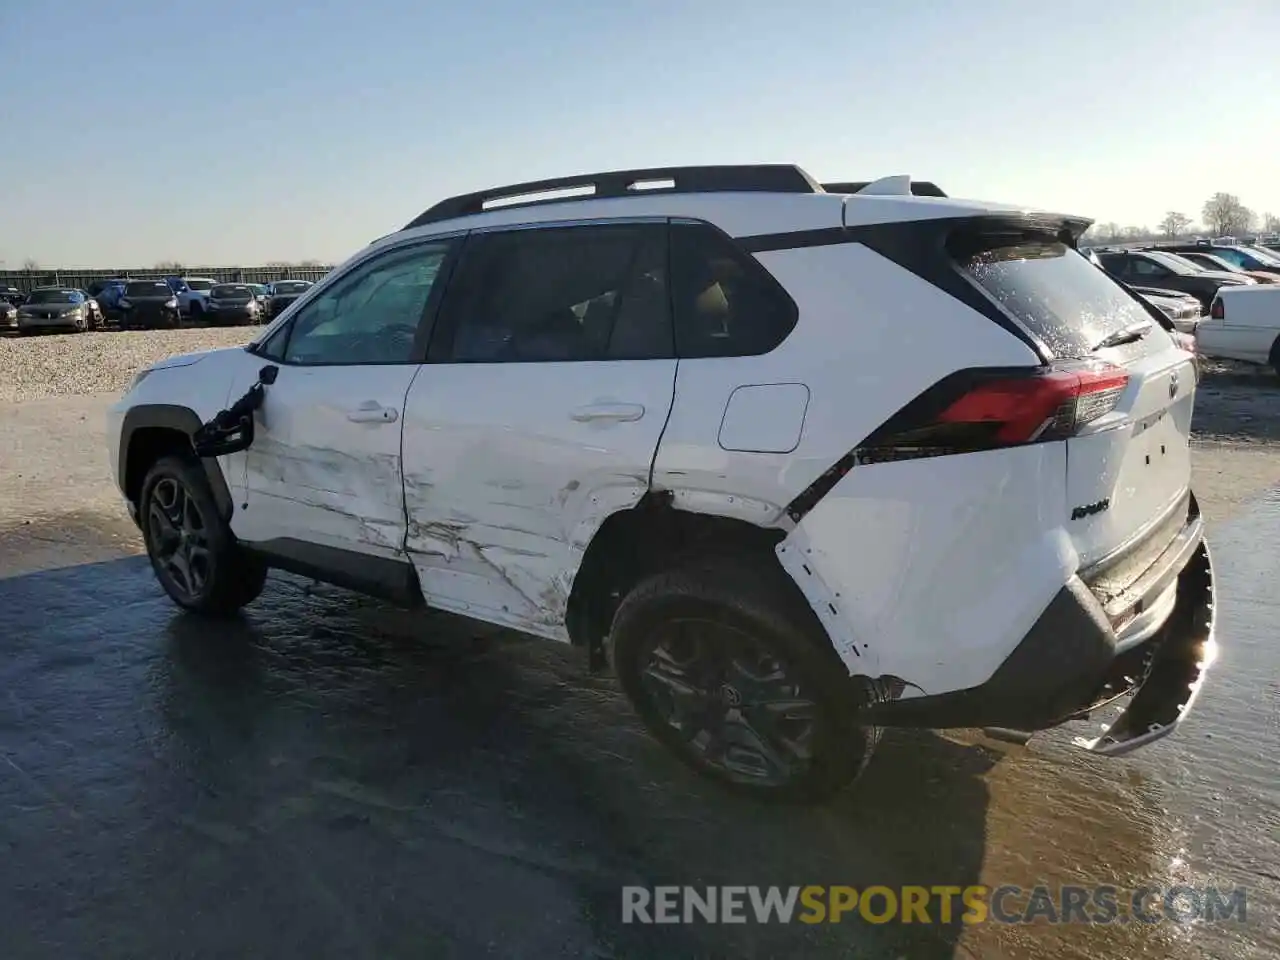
[{"xmin": 282, "ymin": 241, "xmax": 452, "ymax": 365}]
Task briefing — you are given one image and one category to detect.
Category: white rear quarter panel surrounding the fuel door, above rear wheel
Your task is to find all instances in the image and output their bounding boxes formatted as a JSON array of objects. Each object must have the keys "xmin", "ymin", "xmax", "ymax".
[{"xmin": 654, "ymin": 244, "xmax": 1037, "ymax": 525}]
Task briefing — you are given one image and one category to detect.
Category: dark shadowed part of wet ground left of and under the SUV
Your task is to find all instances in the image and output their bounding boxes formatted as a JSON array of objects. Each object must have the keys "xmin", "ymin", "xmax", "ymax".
[{"xmin": 0, "ymin": 558, "xmax": 998, "ymax": 960}]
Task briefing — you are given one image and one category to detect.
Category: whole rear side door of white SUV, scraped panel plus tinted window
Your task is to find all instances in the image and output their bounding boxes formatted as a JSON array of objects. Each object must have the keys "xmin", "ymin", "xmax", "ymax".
[{"xmin": 404, "ymin": 221, "xmax": 676, "ymax": 639}]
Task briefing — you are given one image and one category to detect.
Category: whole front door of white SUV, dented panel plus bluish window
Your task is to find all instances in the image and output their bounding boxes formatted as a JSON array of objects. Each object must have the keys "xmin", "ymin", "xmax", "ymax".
[{"xmin": 225, "ymin": 239, "xmax": 456, "ymax": 580}]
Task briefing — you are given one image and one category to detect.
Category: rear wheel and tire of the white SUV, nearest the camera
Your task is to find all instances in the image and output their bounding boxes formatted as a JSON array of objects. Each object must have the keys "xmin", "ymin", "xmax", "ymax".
[{"xmin": 608, "ymin": 558, "xmax": 879, "ymax": 803}]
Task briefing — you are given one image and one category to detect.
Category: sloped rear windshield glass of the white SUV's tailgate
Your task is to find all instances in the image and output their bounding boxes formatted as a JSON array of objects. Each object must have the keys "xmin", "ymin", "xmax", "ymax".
[{"xmin": 952, "ymin": 239, "xmax": 1152, "ymax": 357}]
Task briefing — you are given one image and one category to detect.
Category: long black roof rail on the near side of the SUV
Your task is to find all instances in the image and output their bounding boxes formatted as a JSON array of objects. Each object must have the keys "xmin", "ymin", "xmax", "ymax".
[{"xmin": 403, "ymin": 164, "xmax": 822, "ymax": 230}]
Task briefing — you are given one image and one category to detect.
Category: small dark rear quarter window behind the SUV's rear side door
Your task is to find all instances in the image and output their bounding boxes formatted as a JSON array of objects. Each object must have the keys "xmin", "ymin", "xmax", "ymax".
[{"xmin": 671, "ymin": 224, "xmax": 797, "ymax": 357}]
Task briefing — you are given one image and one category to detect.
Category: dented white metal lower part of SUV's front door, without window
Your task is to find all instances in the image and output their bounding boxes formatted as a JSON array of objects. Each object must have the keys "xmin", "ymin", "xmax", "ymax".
[{"xmin": 233, "ymin": 365, "xmax": 419, "ymax": 557}]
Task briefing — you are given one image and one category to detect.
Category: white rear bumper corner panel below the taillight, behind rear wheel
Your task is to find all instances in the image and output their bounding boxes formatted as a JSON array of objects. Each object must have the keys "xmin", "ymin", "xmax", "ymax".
[{"xmin": 778, "ymin": 443, "xmax": 1078, "ymax": 696}]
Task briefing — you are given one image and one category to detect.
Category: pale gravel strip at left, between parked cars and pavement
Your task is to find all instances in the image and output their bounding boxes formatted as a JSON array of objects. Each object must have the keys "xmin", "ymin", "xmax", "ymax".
[{"xmin": 0, "ymin": 326, "xmax": 254, "ymax": 401}]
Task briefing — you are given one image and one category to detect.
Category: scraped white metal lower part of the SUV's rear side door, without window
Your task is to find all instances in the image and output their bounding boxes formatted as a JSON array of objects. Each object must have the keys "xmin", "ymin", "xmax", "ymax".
[{"xmin": 404, "ymin": 360, "xmax": 680, "ymax": 640}]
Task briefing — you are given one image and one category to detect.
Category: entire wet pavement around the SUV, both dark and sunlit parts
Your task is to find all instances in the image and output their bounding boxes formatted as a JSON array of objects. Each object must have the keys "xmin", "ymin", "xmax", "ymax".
[{"xmin": 0, "ymin": 492, "xmax": 1280, "ymax": 960}]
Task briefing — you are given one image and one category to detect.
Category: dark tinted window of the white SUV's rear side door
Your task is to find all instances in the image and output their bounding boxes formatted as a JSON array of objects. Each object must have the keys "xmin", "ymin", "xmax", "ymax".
[{"xmin": 431, "ymin": 224, "xmax": 673, "ymax": 364}]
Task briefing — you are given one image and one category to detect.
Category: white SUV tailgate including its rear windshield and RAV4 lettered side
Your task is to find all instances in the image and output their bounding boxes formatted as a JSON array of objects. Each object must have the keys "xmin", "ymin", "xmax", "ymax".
[{"xmin": 957, "ymin": 227, "xmax": 1196, "ymax": 567}]
